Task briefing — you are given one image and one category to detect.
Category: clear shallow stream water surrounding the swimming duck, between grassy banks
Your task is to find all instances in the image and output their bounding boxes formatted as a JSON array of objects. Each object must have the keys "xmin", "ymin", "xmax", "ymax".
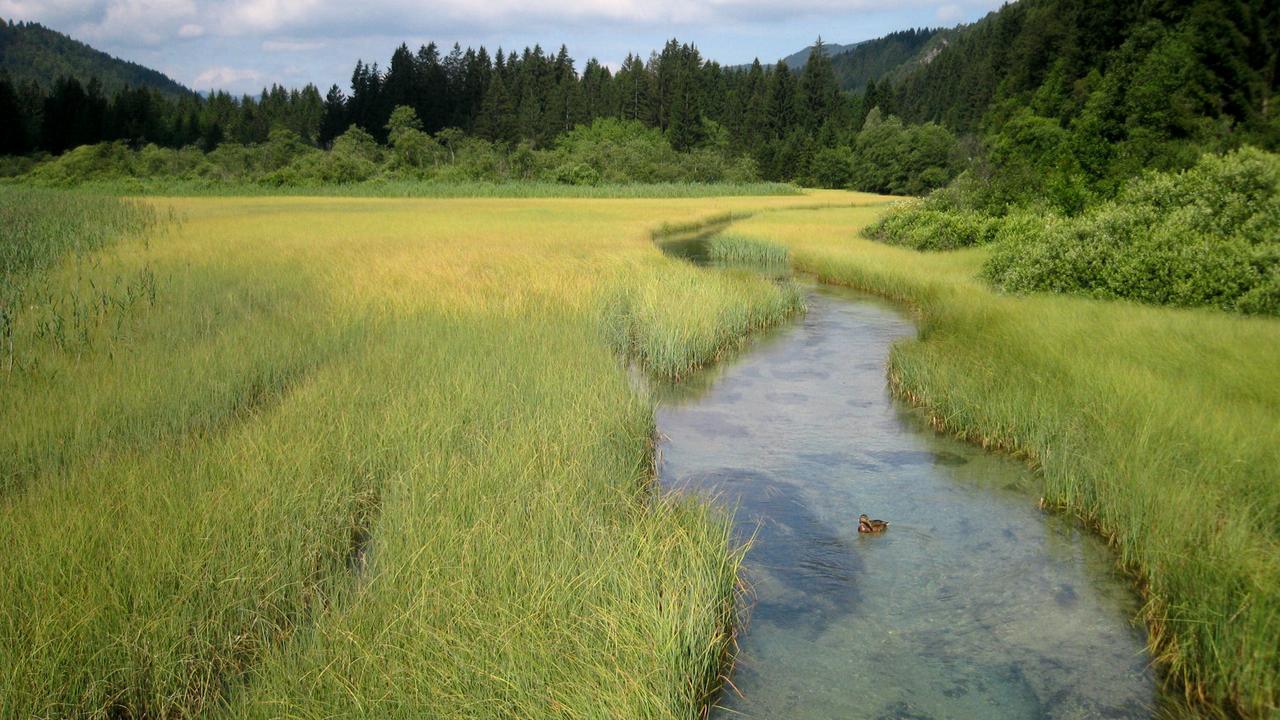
[{"xmin": 658, "ymin": 290, "xmax": 1156, "ymax": 719}]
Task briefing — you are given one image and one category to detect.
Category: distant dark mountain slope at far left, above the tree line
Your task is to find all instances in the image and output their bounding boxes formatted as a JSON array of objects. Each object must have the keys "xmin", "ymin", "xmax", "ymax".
[{"xmin": 0, "ymin": 18, "xmax": 191, "ymax": 97}]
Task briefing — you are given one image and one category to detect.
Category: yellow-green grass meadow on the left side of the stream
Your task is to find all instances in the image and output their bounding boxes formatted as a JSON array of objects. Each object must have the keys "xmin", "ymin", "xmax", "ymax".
[{"xmin": 0, "ymin": 188, "xmax": 870, "ymax": 717}]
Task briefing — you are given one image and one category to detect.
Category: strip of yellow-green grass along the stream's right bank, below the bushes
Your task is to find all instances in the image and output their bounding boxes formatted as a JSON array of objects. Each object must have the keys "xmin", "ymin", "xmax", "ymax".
[{"xmin": 731, "ymin": 208, "xmax": 1280, "ymax": 717}]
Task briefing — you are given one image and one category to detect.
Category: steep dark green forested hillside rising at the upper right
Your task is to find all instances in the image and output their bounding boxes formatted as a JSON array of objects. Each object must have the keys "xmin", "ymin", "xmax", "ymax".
[{"xmin": 882, "ymin": 0, "xmax": 1280, "ymax": 178}]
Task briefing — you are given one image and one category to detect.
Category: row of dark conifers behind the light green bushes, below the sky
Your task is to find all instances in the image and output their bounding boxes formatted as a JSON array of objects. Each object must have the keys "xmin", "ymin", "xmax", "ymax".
[{"xmin": 0, "ymin": 38, "xmax": 955, "ymax": 191}]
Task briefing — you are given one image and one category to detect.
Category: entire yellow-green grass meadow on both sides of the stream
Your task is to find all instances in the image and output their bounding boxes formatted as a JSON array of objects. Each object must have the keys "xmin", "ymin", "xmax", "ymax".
[{"xmin": 0, "ymin": 187, "xmax": 1280, "ymax": 717}]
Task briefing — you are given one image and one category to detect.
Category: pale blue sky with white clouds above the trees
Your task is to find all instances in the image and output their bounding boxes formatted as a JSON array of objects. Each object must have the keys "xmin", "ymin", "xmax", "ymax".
[{"xmin": 0, "ymin": 0, "xmax": 1002, "ymax": 92}]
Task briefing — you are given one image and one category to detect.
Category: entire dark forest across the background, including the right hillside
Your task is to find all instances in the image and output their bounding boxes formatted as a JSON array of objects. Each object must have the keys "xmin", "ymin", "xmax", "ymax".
[{"xmin": 0, "ymin": 0, "xmax": 1280, "ymax": 202}]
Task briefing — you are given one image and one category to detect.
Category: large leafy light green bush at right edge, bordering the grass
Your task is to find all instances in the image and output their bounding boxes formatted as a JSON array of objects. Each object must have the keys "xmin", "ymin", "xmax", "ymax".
[{"xmin": 984, "ymin": 149, "xmax": 1280, "ymax": 315}]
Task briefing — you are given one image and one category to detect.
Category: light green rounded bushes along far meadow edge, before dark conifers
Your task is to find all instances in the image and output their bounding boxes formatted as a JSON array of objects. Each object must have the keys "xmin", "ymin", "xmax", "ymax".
[{"xmin": 12, "ymin": 108, "xmax": 758, "ymax": 187}]
